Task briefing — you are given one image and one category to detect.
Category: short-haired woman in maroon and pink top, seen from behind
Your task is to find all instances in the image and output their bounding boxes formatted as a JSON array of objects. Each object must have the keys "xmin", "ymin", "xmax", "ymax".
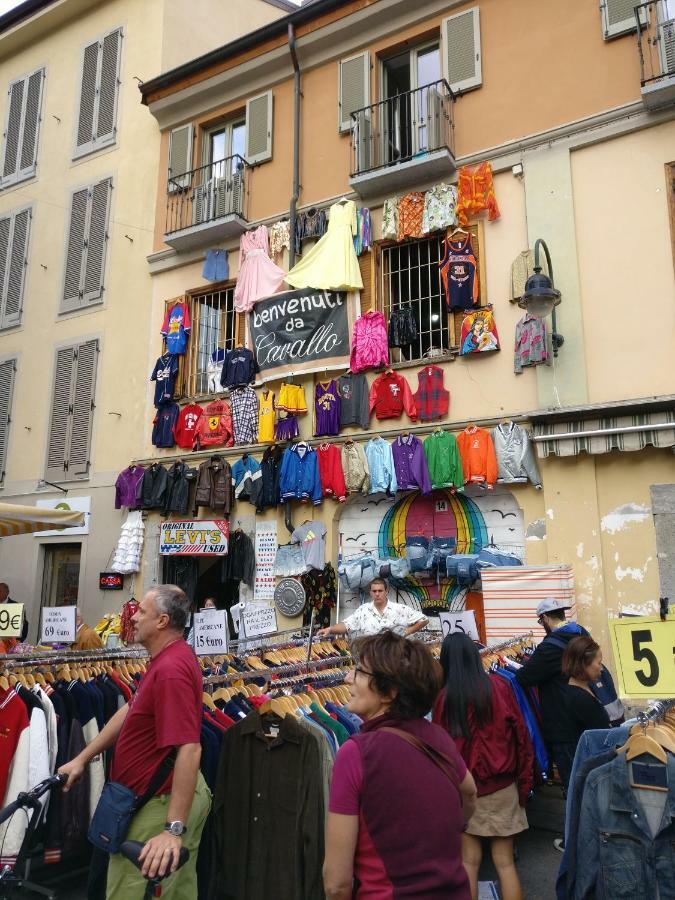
[{"xmin": 323, "ymin": 631, "xmax": 476, "ymax": 900}]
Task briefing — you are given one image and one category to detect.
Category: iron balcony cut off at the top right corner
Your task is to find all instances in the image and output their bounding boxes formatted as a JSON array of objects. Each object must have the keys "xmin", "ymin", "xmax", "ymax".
[{"xmin": 635, "ymin": 0, "xmax": 675, "ymax": 109}]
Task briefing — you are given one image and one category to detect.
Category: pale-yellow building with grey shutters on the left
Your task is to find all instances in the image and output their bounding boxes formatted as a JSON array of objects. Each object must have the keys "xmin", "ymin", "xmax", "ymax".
[{"xmin": 0, "ymin": 0, "xmax": 294, "ymax": 640}]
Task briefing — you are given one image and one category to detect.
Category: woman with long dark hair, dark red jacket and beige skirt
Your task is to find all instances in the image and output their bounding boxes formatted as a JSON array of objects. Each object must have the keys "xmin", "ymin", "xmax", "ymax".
[{"xmin": 433, "ymin": 632, "xmax": 534, "ymax": 900}]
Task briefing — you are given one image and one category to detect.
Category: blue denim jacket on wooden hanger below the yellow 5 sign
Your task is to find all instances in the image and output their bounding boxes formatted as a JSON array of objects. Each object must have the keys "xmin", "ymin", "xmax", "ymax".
[{"xmin": 574, "ymin": 753, "xmax": 675, "ymax": 900}]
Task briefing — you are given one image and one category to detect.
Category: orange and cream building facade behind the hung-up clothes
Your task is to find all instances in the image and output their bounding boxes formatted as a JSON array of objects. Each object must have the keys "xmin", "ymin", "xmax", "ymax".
[{"xmin": 135, "ymin": 0, "xmax": 675, "ymax": 646}]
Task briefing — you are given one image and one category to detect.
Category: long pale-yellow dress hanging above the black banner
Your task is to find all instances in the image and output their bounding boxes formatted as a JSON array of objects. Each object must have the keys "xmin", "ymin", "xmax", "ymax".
[{"xmin": 286, "ymin": 200, "xmax": 363, "ymax": 291}]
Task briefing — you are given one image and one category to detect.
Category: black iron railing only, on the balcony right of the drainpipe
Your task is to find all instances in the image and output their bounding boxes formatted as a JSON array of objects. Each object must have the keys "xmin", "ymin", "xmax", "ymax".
[{"xmin": 351, "ymin": 79, "xmax": 454, "ymax": 178}]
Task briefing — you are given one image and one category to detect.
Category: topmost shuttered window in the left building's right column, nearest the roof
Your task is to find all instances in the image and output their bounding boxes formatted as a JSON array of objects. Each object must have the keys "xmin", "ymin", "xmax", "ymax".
[{"xmin": 74, "ymin": 28, "xmax": 122, "ymax": 158}]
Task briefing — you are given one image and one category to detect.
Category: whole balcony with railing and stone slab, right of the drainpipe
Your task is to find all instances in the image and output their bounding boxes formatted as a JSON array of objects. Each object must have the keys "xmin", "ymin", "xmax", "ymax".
[{"xmin": 350, "ymin": 79, "xmax": 455, "ymax": 196}]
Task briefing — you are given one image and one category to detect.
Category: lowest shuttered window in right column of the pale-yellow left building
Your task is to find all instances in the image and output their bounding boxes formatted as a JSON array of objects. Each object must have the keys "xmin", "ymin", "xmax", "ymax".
[{"xmin": 45, "ymin": 340, "xmax": 98, "ymax": 482}]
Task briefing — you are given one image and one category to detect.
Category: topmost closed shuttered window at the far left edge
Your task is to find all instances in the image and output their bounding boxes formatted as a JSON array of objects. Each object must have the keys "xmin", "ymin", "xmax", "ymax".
[{"xmin": 1, "ymin": 69, "xmax": 45, "ymax": 187}]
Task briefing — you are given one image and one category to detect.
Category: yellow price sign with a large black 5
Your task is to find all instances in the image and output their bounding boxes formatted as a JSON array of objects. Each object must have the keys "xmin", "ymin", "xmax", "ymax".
[{"xmin": 609, "ymin": 616, "xmax": 675, "ymax": 699}]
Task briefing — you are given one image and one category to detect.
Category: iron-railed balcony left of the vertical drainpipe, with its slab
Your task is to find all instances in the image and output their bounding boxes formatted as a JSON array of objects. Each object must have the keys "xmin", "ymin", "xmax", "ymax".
[{"xmin": 164, "ymin": 154, "xmax": 249, "ymax": 250}]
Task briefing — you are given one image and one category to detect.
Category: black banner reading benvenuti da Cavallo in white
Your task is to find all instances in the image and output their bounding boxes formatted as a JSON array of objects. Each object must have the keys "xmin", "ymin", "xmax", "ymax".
[{"xmin": 249, "ymin": 288, "xmax": 349, "ymax": 381}]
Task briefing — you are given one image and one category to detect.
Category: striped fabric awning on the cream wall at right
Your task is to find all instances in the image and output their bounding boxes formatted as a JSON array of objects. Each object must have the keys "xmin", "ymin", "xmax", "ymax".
[{"xmin": 533, "ymin": 410, "xmax": 675, "ymax": 459}]
